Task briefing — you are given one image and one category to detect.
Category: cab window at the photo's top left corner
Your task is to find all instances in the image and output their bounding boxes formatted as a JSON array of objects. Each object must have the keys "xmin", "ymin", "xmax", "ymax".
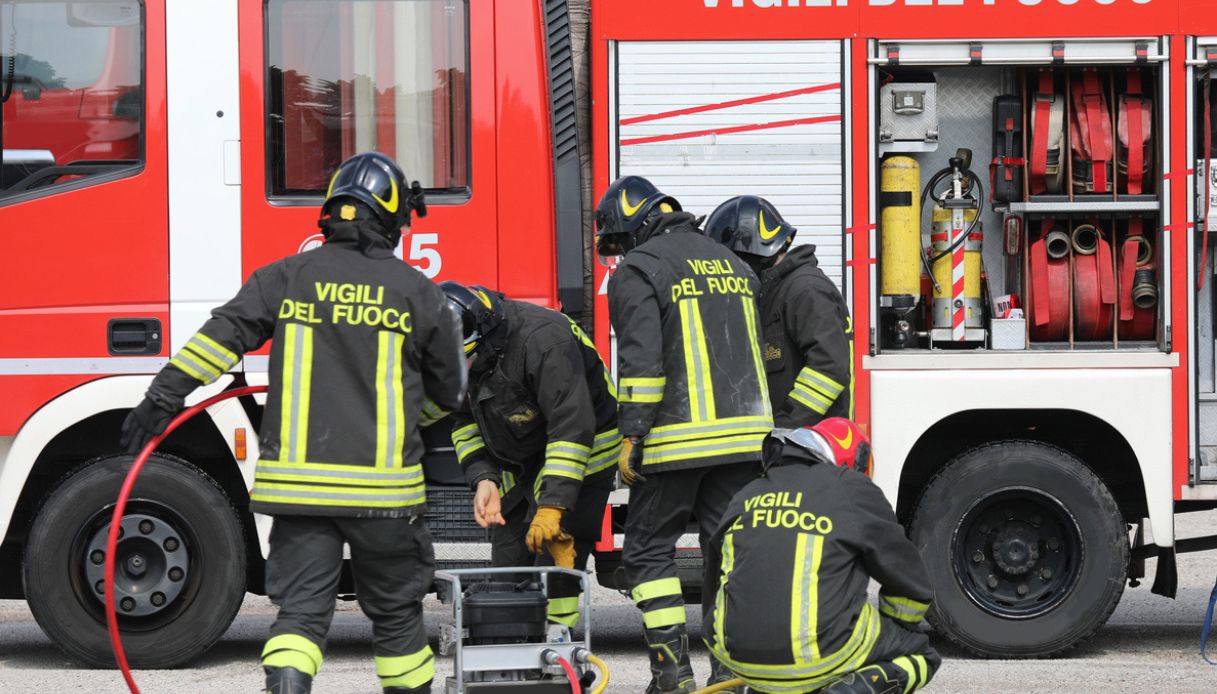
[{"xmin": 0, "ymin": 0, "xmax": 144, "ymax": 205}]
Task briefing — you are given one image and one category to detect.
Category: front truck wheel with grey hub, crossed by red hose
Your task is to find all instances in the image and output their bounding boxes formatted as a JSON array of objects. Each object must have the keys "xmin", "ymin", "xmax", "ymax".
[{"xmin": 24, "ymin": 454, "xmax": 246, "ymax": 668}]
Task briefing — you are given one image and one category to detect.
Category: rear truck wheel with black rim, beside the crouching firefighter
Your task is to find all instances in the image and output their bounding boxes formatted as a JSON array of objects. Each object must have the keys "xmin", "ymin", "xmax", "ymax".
[{"xmin": 912, "ymin": 441, "xmax": 1128, "ymax": 657}]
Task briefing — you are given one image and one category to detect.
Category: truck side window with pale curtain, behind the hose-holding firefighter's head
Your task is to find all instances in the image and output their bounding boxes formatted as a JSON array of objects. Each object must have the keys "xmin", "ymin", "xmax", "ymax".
[{"xmin": 265, "ymin": 0, "xmax": 470, "ymax": 196}]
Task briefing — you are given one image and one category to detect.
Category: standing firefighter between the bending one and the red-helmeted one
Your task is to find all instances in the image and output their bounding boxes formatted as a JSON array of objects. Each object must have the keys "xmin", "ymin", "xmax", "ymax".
[{"xmin": 596, "ymin": 177, "xmax": 773, "ymax": 693}]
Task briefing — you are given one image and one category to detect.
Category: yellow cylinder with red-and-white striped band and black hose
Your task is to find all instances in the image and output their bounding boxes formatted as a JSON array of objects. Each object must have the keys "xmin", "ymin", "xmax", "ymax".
[{"xmin": 930, "ymin": 206, "xmax": 983, "ymax": 331}]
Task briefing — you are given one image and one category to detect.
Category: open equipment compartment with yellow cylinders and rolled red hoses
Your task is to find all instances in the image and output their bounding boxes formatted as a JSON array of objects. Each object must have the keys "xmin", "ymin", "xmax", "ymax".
[{"xmin": 871, "ymin": 43, "xmax": 1166, "ymax": 353}]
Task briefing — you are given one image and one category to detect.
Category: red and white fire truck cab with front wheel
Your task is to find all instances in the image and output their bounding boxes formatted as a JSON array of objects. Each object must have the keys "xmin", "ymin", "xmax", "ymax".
[{"xmin": 0, "ymin": 0, "xmax": 584, "ymax": 667}]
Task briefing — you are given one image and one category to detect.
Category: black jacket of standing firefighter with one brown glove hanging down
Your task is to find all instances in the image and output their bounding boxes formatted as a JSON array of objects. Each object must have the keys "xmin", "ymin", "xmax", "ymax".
[{"xmin": 609, "ymin": 212, "xmax": 773, "ymax": 471}]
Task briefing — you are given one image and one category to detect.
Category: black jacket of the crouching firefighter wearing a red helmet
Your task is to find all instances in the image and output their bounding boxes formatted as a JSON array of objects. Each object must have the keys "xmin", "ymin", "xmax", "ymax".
[{"xmin": 705, "ymin": 457, "xmax": 933, "ymax": 692}]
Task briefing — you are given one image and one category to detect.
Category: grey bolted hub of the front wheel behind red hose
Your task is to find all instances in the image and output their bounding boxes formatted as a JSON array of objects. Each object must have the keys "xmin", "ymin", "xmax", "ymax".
[{"xmin": 84, "ymin": 514, "xmax": 190, "ymax": 617}]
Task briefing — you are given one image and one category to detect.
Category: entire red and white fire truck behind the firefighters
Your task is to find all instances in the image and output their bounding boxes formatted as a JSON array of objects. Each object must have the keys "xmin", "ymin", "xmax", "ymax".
[{"xmin": 7, "ymin": 0, "xmax": 1217, "ymax": 666}]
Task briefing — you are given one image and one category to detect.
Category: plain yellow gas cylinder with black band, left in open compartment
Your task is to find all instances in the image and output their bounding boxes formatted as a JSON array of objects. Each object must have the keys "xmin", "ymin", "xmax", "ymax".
[{"xmin": 879, "ymin": 156, "xmax": 921, "ymax": 301}]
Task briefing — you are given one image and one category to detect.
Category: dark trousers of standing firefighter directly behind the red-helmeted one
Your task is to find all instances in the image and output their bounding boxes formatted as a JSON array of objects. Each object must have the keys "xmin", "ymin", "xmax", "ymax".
[{"xmin": 621, "ymin": 463, "xmax": 761, "ymax": 629}]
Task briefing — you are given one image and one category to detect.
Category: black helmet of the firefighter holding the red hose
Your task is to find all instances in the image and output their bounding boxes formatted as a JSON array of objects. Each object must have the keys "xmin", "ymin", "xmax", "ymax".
[{"xmin": 321, "ymin": 152, "xmax": 427, "ymax": 233}]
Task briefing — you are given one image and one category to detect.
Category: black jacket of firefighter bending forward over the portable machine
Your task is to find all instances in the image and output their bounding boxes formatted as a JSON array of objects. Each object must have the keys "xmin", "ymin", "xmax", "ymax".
[{"xmin": 453, "ymin": 300, "xmax": 621, "ymax": 511}]
